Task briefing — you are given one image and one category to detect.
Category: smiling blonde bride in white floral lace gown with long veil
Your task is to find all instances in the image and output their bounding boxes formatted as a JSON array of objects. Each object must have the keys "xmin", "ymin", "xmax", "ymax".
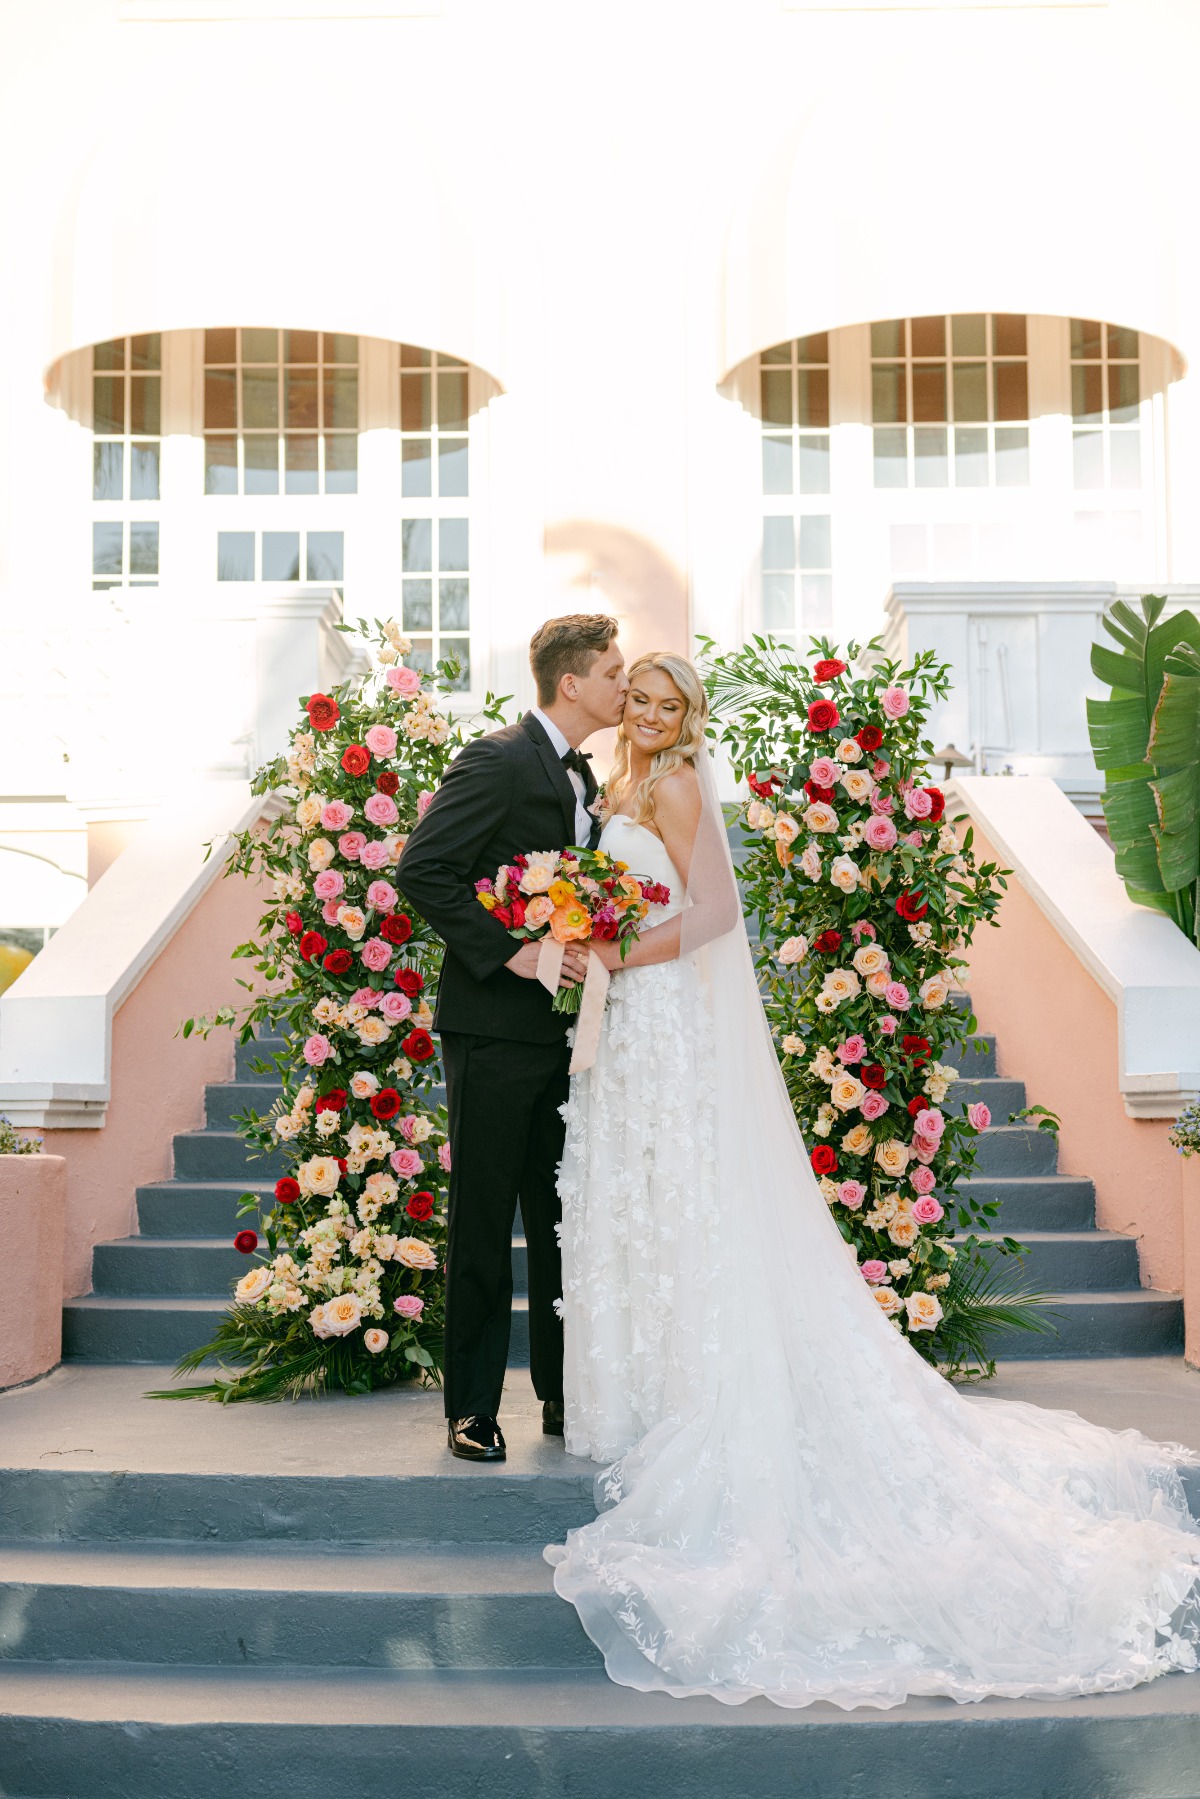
[{"xmin": 545, "ymin": 653, "xmax": 1200, "ymax": 1707}]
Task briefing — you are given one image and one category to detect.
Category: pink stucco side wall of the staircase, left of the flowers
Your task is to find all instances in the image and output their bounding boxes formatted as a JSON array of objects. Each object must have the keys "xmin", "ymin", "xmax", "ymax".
[{"xmin": 45, "ymin": 874, "xmax": 263, "ymax": 1299}]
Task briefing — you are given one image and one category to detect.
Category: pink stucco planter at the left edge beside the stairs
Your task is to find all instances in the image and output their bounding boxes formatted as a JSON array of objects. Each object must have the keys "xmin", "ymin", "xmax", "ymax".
[{"xmin": 0, "ymin": 1155, "xmax": 67, "ymax": 1387}]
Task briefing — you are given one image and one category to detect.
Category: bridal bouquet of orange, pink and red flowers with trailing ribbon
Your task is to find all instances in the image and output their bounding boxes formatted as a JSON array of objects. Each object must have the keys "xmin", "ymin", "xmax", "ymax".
[{"xmin": 475, "ymin": 849, "xmax": 671, "ymax": 1013}]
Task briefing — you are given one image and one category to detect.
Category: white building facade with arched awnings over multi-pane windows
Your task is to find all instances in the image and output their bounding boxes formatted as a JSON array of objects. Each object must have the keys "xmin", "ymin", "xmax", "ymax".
[{"xmin": 0, "ymin": 0, "xmax": 1200, "ymax": 941}]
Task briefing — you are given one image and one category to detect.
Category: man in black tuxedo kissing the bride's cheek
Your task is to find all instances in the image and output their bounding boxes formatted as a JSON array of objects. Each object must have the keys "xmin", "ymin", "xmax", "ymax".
[{"xmin": 396, "ymin": 613, "xmax": 630, "ymax": 1461}]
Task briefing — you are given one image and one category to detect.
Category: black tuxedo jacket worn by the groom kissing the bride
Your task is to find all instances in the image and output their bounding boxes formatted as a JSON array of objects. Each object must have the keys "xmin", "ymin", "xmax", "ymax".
[{"xmin": 396, "ymin": 712, "xmax": 597, "ymax": 1043}]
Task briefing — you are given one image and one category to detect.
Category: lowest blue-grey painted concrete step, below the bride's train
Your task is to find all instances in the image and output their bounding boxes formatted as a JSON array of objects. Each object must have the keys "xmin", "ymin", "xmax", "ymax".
[{"xmin": 0, "ymin": 1662, "xmax": 1200, "ymax": 1799}]
